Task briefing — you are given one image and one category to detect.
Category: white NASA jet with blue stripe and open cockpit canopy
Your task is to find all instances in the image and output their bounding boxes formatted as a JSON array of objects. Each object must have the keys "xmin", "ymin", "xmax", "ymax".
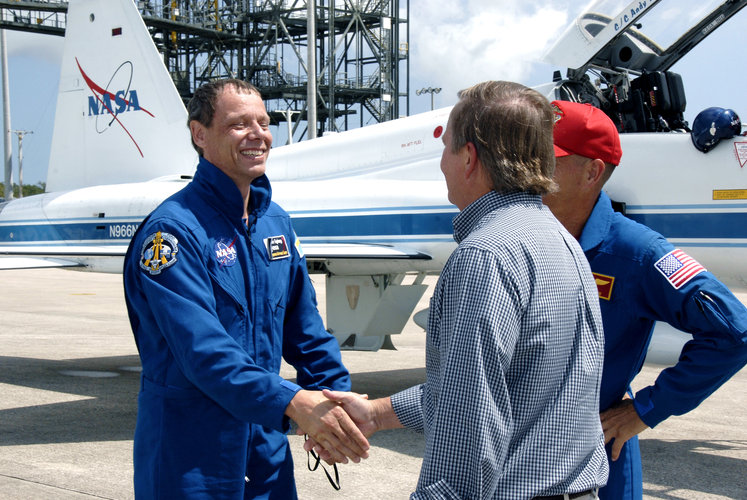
[{"xmin": 0, "ymin": 0, "xmax": 747, "ymax": 353}]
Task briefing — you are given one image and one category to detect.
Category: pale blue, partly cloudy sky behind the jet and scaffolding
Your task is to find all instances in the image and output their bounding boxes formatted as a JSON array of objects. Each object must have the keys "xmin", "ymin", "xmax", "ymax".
[{"xmin": 0, "ymin": 0, "xmax": 747, "ymax": 188}]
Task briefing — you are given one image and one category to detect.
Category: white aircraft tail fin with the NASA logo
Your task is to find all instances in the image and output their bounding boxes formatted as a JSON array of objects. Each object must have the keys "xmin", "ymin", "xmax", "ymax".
[{"xmin": 47, "ymin": 0, "xmax": 197, "ymax": 191}]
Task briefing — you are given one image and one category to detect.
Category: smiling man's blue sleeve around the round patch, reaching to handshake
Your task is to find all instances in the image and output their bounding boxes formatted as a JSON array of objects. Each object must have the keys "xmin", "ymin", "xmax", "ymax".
[{"xmin": 124, "ymin": 221, "xmax": 300, "ymax": 431}]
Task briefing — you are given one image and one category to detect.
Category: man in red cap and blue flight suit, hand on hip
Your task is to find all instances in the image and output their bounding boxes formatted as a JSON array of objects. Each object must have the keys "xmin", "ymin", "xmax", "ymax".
[{"xmin": 544, "ymin": 101, "xmax": 747, "ymax": 500}]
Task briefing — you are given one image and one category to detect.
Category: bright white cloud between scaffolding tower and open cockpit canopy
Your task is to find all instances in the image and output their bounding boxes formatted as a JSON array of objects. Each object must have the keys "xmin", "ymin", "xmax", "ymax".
[{"xmin": 410, "ymin": 0, "xmax": 579, "ymax": 104}]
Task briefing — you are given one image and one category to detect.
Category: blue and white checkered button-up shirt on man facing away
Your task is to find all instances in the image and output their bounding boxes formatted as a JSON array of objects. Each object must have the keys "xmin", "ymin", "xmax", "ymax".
[{"xmin": 392, "ymin": 192, "xmax": 607, "ymax": 500}]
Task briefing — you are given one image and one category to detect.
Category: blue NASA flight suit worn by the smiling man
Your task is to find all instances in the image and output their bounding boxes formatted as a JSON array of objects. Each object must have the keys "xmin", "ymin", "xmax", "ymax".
[{"xmin": 124, "ymin": 158, "xmax": 350, "ymax": 500}]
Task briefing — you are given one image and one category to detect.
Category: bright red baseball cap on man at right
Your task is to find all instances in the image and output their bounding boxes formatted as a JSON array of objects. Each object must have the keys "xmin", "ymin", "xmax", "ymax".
[{"xmin": 551, "ymin": 101, "xmax": 622, "ymax": 165}]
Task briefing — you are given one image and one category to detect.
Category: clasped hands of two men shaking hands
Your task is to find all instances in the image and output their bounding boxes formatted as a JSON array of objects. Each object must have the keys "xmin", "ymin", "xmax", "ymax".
[{"xmin": 285, "ymin": 389, "xmax": 402, "ymax": 464}]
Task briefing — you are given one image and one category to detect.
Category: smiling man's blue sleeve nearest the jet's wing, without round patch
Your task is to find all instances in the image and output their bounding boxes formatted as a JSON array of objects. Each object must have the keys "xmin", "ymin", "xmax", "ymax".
[{"xmin": 283, "ymin": 229, "xmax": 351, "ymax": 391}]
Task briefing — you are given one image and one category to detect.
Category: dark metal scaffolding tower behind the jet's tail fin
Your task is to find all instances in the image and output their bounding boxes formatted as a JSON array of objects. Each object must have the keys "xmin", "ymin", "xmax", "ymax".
[{"xmin": 0, "ymin": 0, "xmax": 409, "ymax": 140}]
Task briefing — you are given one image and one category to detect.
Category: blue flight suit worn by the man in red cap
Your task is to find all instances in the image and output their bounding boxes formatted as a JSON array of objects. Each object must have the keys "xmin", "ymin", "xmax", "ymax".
[{"xmin": 579, "ymin": 192, "xmax": 747, "ymax": 500}]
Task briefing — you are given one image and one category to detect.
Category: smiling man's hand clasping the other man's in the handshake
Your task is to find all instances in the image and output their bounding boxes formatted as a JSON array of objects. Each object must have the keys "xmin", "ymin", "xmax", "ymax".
[{"xmin": 285, "ymin": 390, "xmax": 369, "ymax": 463}]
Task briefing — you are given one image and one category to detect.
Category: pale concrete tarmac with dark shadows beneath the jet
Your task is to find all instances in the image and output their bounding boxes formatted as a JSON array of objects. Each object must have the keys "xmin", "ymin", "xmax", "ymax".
[{"xmin": 0, "ymin": 269, "xmax": 747, "ymax": 500}]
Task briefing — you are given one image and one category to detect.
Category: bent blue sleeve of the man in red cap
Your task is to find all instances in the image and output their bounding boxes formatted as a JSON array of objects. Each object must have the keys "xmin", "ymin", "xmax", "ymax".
[{"xmin": 634, "ymin": 238, "xmax": 747, "ymax": 427}]
